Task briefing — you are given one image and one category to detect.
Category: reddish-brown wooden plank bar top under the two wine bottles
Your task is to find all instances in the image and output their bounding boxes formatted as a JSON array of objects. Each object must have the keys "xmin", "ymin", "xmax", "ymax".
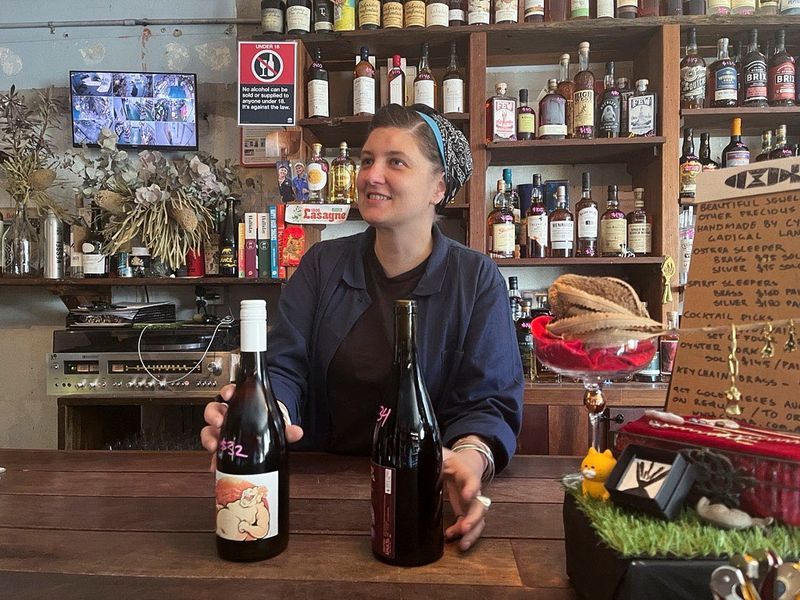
[{"xmin": 0, "ymin": 449, "xmax": 579, "ymax": 600}]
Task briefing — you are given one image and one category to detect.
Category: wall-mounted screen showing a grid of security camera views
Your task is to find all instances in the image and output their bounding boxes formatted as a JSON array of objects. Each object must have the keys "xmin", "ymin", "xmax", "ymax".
[{"xmin": 69, "ymin": 71, "xmax": 197, "ymax": 150}]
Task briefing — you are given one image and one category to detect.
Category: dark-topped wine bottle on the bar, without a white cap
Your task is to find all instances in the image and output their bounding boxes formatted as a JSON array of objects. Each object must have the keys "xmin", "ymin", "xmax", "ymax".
[{"xmin": 370, "ymin": 300, "xmax": 444, "ymax": 567}]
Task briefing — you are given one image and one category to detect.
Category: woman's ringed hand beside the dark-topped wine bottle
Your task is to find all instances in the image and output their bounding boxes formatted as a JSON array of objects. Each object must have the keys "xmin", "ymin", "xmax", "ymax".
[{"xmin": 443, "ymin": 448, "xmax": 489, "ymax": 550}]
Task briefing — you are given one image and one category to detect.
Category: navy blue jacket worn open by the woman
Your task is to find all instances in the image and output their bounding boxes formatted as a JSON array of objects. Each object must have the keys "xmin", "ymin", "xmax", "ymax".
[{"xmin": 268, "ymin": 226, "xmax": 523, "ymax": 471}]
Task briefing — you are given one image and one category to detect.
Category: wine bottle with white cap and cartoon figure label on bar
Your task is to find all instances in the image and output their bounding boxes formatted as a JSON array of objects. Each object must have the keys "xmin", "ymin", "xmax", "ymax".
[{"xmin": 215, "ymin": 300, "xmax": 289, "ymax": 562}]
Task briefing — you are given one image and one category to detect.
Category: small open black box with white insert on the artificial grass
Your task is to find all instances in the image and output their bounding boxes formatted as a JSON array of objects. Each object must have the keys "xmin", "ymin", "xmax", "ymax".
[{"xmin": 606, "ymin": 444, "xmax": 695, "ymax": 521}]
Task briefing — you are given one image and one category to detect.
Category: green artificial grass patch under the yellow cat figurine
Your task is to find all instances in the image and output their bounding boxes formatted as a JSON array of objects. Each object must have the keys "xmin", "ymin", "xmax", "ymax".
[{"xmin": 567, "ymin": 488, "xmax": 800, "ymax": 559}]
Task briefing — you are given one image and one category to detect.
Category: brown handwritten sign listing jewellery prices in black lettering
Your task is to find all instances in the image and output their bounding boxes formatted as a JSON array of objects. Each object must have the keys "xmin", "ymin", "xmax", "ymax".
[{"xmin": 667, "ymin": 158, "xmax": 800, "ymax": 432}]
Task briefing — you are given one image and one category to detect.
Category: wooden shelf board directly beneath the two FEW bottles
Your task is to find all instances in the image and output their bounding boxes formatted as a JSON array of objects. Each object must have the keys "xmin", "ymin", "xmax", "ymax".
[{"xmin": 486, "ymin": 136, "xmax": 666, "ymax": 166}]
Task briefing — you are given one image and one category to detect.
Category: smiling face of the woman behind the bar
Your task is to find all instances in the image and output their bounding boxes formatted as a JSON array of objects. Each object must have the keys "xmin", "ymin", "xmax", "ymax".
[{"xmin": 356, "ymin": 127, "xmax": 445, "ymax": 229}]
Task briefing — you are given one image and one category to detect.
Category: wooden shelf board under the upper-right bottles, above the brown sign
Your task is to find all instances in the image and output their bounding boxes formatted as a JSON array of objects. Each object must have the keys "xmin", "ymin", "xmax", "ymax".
[{"xmin": 681, "ymin": 106, "xmax": 800, "ymax": 137}]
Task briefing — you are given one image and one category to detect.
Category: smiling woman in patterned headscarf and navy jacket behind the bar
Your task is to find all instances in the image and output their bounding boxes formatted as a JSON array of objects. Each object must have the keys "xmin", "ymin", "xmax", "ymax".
[{"xmin": 202, "ymin": 105, "xmax": 523, "ymax": 550}]
